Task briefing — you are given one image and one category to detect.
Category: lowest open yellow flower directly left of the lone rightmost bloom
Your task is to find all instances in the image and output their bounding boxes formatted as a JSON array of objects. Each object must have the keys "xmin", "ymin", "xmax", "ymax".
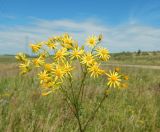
[{"xmin": 88, "ymin": 64, "xmax": 104, "ymax": 78}]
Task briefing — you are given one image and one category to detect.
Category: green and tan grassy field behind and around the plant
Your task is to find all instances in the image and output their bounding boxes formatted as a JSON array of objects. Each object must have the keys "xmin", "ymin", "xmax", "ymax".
[{"xmin": 0, "ymin": 55, "xmax": 160, "ymax": 132}]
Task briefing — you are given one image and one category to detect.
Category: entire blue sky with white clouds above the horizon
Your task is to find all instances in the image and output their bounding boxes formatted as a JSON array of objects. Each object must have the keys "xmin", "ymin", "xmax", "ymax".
[{"xmin": 0, "ymin": 0, "xmax": 160, "ymax": 54}]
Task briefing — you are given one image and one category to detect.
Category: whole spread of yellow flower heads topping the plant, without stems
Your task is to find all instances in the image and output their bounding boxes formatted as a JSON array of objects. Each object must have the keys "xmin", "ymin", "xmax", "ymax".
[{"xmin": 16, "ymin": 34, "xmax": 127, "ymax": 96}]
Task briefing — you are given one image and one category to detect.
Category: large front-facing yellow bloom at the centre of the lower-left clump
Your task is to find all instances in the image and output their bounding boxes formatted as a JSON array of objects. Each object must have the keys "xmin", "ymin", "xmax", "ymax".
[{"xmin": 52, "ymin": 65, "xmax": 65, "ymax": 80}]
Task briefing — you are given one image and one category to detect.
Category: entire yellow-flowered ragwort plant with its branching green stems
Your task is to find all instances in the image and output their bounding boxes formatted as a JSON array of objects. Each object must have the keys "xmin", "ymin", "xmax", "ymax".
[{"xmin": 16, "ymin": 34, "xmax": 128, "ymax": 132}]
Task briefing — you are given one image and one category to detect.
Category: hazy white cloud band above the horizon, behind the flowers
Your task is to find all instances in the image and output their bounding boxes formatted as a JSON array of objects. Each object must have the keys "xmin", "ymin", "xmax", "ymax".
[{"xmin": 0, "ymin": 19, "xmax": 160, "ymax": 54}]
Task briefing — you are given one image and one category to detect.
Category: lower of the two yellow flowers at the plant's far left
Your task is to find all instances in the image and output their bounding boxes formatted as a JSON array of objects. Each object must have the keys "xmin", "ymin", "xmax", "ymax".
[{"xmin": 19, "ymin": 60, "xmax": 30, "ymax": 74}]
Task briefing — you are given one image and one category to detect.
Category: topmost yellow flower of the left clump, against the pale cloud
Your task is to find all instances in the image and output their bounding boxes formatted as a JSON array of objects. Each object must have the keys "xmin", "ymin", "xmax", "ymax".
[{"xmin": 62, "ymin": 34, "xmax": 73, "ymax": 49}]
